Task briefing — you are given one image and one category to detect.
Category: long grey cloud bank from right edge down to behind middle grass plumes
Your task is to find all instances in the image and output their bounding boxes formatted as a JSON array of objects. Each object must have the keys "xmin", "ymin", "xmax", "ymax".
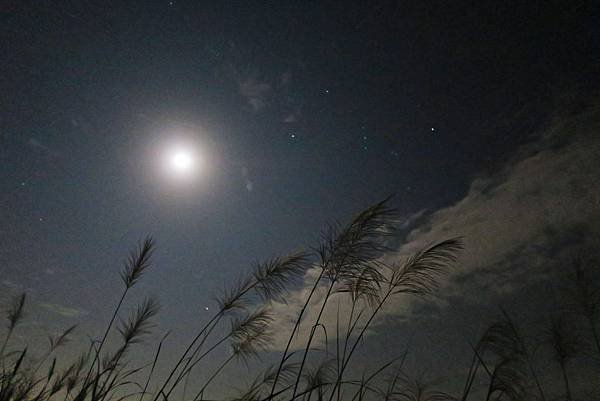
[{"xmin": 268, "ymin": 101, "xmax": 600, "ymax": 349}]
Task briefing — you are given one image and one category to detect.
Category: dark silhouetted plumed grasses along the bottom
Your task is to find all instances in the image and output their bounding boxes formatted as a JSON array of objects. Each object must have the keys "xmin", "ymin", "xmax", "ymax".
[{"xmin": 0, "ymin": 200, "xmax": 600, "ymax": 401}]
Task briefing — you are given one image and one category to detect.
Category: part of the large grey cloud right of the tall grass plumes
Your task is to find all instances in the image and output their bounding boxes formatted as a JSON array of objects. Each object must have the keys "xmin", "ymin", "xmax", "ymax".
[{"xmin": 399, "ymin": 104, "xmax": 600, "ymax": 302}]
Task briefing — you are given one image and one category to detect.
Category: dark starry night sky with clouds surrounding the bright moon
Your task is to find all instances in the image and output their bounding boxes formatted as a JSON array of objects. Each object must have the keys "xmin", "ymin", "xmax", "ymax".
[{"xmin": 0, "ymin": 0, "xmax": 600, "ymax": 396}]
